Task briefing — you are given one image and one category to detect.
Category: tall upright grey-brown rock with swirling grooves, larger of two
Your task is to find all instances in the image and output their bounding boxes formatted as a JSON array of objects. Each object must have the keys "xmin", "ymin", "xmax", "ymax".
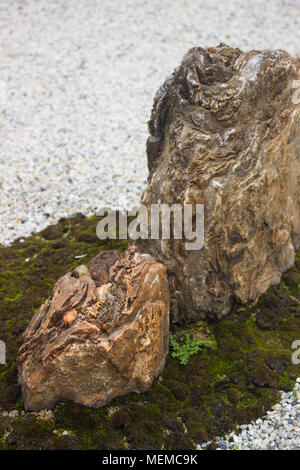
[{"xmin": 137, "ymin": 44, "xmax": 300, "ymax": 322}]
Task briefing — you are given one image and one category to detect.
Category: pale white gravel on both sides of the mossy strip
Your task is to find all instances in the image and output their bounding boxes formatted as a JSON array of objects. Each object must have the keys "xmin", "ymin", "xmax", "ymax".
[{"xmin": 0, "ymin": 0, "xmax": 300, "ymax": 449}]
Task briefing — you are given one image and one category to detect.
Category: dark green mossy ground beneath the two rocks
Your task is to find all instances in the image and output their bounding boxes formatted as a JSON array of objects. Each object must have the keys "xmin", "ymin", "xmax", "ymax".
[{"xmin": 0, "ymin": 215, "xmax": 300, "ymax": 449}]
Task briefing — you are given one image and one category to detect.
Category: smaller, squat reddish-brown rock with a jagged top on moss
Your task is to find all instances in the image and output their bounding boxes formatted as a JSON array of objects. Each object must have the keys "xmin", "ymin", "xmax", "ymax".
[{"xmin": 18, "ymin": 247, "xmax": 169, "ymax": 411}]
